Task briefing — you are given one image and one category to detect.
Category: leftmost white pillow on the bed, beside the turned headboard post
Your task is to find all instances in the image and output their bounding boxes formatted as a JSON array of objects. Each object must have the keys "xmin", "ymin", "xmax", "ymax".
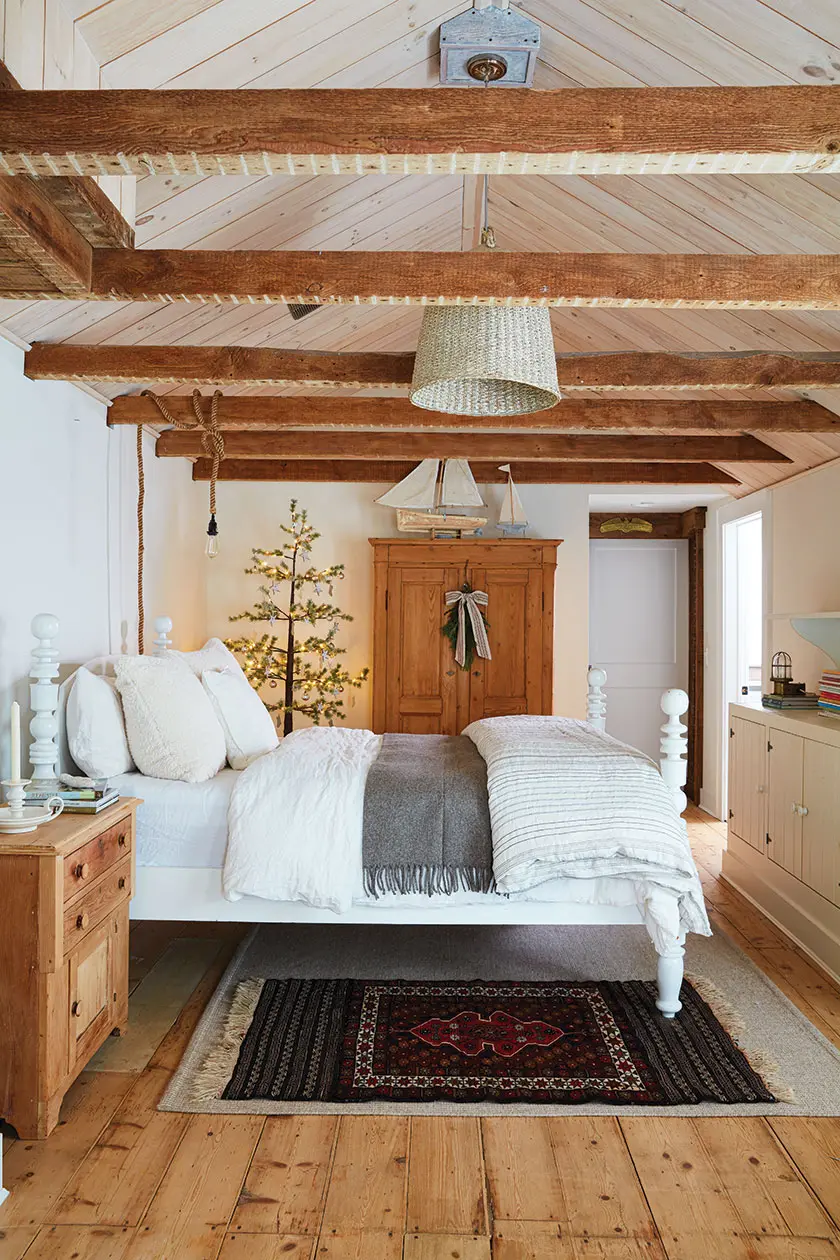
[{"xmin": 65, "ymin": 668, "xmax": 135, "ymax": 779}]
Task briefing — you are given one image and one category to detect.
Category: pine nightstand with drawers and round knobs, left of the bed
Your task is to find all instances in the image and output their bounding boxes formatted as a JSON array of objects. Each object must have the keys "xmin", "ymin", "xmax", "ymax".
[{"xmin": 0, "ymin": 798, "xmax": 140, "ymax": 1138}]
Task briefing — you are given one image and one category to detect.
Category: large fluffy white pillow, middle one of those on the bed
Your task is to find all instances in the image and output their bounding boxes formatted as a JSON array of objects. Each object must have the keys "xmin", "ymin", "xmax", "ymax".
[{"xmin": 115, "ymin": 653, "xmax": 225, "ymax": 784}]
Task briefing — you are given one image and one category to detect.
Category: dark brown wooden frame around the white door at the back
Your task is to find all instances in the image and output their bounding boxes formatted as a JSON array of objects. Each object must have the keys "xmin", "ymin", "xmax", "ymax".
[{"xmin": 589, "ymin": 508, "xmax": 707, "ymax": 804}]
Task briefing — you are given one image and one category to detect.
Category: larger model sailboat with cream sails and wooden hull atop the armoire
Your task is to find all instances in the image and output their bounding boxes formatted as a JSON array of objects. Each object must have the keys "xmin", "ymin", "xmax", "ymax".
[{"xmin": 377, "ymin": 460, "xmax": 487, "ymax": 537}]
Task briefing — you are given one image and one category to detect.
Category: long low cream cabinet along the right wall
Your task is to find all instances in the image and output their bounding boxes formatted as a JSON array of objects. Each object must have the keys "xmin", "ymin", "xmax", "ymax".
[{"xmin": 723, "ymin": 704, "xmax": 840, "ymax": 975}]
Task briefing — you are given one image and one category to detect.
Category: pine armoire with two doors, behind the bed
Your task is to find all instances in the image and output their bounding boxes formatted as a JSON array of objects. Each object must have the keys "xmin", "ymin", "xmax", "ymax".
[{"xmin": 370, "ymin": 538, "xmax": 562, "ymax": 735}]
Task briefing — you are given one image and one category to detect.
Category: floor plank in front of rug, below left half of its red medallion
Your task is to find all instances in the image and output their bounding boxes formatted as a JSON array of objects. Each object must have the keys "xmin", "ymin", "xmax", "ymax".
[{"xmin": 407, "ymin": 1115, "xmax": 487, "ymax": 1245}]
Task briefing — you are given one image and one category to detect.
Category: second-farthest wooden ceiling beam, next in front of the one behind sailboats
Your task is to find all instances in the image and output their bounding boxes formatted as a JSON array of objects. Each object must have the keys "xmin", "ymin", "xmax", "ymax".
[{"xmin": 157, "ymin": 428, "xmax": 791, "ymax": 464}]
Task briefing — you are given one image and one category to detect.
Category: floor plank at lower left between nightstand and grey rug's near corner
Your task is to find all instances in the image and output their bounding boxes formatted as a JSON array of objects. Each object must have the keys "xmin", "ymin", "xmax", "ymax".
[{"xmin": 49, "ymin": 1067, "xmax": 189, "ymax": 1226}]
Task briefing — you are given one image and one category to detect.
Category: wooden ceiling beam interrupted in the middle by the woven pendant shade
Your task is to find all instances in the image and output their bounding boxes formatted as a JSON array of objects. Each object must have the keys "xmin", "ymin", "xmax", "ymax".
[{"xmin": 25, "ymin": 345, "xmax": 840, "ymax": 393}]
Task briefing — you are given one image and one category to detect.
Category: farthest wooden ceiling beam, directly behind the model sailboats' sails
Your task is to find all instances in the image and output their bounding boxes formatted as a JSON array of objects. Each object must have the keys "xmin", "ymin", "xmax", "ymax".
[{"xmin": 193, "ymin": 459, "xmax": 739, "ymax": 485}]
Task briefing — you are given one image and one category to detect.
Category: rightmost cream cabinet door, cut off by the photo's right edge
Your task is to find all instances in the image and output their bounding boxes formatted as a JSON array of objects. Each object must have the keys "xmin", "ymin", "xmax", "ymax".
[{"xmin": 801, "ymin": 740, "xmax": 840, "ymax": 906}]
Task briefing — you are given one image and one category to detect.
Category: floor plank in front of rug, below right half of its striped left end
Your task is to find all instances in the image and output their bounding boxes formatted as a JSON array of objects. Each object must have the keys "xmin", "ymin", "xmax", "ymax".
[{"xmin": 230, "ymin": 1115, "xmax": 338, "ymax": 1236}]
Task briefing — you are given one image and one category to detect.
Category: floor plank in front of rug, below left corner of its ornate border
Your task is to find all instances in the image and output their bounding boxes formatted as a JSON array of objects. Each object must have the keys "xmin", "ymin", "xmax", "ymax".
[{"xmin": 319, "ymin": 1115, "xmax": 408, "ymax": 1234}]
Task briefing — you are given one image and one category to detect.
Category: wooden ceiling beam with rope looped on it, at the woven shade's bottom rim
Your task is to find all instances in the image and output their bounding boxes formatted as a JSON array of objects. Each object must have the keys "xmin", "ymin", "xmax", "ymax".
[{"xmin": 108, "ymin": 394, "xmax": 840, "ymax": 433}]
